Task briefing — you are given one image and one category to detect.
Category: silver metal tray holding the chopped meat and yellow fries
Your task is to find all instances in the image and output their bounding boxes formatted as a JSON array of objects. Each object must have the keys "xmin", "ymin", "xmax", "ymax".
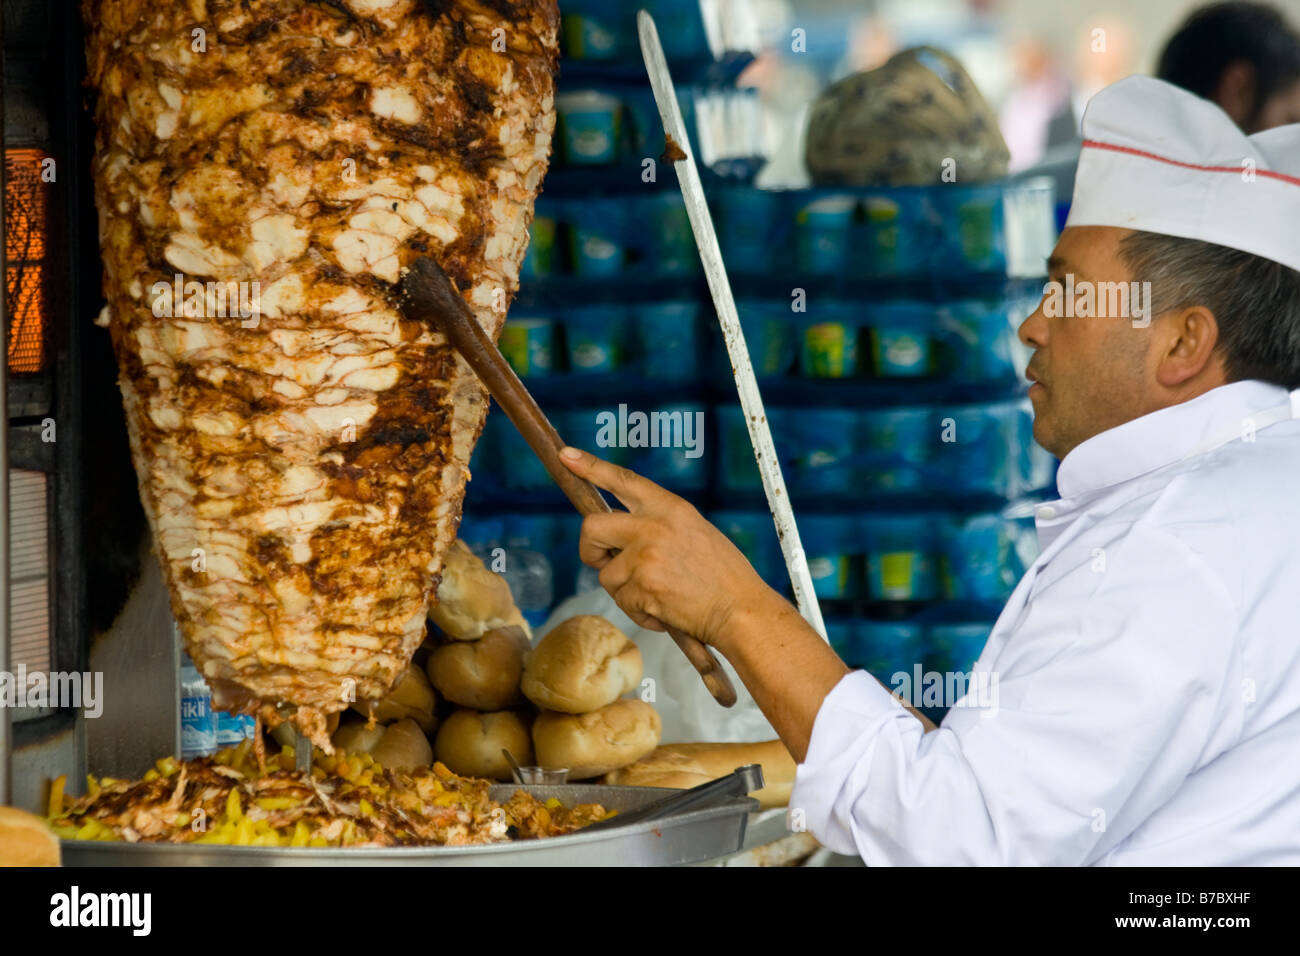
[{"xmin": 55, "ymin": 783, "xmax": 758, "ymax": 866}]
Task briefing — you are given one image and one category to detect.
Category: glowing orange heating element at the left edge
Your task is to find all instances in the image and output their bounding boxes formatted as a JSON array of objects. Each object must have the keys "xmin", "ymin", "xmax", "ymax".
[{"xmin": 4, "ymin": 148, "xmax": 49, "ymax": 375}]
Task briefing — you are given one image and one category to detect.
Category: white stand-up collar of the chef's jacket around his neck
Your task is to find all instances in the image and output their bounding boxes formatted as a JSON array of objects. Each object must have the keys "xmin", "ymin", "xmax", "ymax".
[{"xmin": 1057, "ymin": 380, "xmax": 1290, "ymax": 498}]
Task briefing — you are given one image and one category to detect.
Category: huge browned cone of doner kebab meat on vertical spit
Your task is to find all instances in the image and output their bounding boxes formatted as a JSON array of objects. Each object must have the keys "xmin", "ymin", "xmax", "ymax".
[{"xmin": 83, "ymin": 0, "xmax": 559, "ymax": 750}]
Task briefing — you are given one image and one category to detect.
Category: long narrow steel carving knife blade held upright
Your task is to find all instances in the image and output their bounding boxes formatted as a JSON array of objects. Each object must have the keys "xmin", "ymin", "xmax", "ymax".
[{"xmin": 637, "ymin": 10, "xmax": 826, "ymax": 639}]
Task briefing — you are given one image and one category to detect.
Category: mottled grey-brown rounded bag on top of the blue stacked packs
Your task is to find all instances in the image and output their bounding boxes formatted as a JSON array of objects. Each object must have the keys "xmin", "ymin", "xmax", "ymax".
[{"xmin": 805, "ymin": 47, "xmax": 1010, "ymax": 186}]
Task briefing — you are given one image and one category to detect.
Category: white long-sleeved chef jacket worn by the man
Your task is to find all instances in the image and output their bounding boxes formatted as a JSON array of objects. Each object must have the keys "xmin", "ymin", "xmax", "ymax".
[{"xmin": 790, "ymin": 381, "xmax": 1300, "ymax": 865}]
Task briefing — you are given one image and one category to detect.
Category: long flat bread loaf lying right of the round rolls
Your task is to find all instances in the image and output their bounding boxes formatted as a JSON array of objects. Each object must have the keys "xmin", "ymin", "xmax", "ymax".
[{"xmin": 602, "ymin": 740, "xmax": 796, "ymax": 808}]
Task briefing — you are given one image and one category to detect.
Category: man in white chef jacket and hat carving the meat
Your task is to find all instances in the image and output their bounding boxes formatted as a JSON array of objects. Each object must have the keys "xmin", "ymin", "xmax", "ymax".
[{"xmin": 564, "ymin": 77, "xmax": 1300, "ymax": 865}]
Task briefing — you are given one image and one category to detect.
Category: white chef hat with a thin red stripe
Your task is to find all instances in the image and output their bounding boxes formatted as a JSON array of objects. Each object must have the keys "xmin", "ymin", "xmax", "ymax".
[{"xmin": 1066, "ymin": 77, "xmax": 1300, "ymax": 271}]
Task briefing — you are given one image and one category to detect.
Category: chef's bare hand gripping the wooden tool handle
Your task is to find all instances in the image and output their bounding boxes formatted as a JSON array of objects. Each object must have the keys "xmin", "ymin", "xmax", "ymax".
[{"xmin": 560, "ymin": 447, "xmax": 784, "ymax": 654}]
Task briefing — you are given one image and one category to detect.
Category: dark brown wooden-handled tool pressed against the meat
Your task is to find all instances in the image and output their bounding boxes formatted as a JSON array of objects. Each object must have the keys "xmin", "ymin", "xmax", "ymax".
[{"xmin": 402, "ymin": 258, "xmax": 736, "ymax": 708}]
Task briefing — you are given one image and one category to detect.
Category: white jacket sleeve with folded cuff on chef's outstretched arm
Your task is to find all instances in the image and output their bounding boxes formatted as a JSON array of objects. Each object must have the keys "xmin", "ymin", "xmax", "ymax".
[{"xmin": 790, "ymin": 525, "xmax": 1242, "ymax": 865}]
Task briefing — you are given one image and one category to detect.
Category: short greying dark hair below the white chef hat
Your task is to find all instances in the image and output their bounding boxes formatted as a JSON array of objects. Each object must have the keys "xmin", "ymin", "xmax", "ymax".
[{"xmin": 1119, "ymin": 232, "xmax": 1300, "ymax": 389}]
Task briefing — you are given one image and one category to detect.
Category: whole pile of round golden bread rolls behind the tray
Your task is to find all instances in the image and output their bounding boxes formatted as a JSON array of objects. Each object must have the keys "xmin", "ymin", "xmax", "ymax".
[{"xmin": 332, "ymin": 541, "xmax": 662, "ymax": 780}]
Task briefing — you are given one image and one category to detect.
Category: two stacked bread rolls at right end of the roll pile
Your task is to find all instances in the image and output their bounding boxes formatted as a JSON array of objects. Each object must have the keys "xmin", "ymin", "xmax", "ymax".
[{"xmin": 521, "ymin": 614, "xmax": 663, "ymax": 780}]
